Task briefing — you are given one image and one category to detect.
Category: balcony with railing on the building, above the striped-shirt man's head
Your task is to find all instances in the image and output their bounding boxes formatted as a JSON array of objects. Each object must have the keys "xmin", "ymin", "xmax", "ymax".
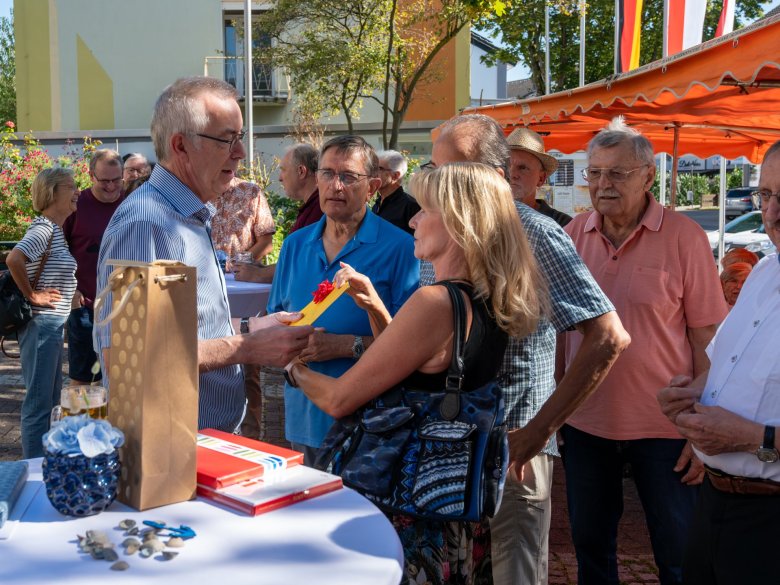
[{"xmin": 203, "ymin": 55, "xmax": 291, "ymax": 105}]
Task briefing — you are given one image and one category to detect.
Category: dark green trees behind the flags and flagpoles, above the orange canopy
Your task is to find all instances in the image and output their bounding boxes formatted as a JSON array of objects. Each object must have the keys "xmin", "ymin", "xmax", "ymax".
[{"xmin": 478, "ymin": 0, "xmax": 769, "ymax": 93}]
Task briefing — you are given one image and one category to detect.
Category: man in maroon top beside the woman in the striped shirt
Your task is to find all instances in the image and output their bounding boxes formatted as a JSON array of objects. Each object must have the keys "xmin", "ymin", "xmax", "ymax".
[{"xmin": 62, "ymin": 148, "xmax": 125, "ymax": 384}]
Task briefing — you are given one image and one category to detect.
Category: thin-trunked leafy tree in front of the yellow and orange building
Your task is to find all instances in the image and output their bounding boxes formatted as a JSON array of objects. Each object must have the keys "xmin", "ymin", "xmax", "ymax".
[{"xmin": 256, "ymin": 0, "xmax": 506, "ymax": 148}]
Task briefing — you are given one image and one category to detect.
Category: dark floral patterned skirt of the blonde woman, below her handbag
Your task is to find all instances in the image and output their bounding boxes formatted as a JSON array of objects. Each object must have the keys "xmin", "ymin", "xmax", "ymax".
[{"xmin": 390, "ymin": 515, "xmax": 493, "ymax": 585}]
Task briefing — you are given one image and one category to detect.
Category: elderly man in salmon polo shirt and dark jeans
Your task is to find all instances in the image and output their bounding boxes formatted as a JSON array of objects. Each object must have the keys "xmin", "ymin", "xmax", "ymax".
[{"xmin": 559, "ymin": 118, "xmax": 728, "ymax": 585}]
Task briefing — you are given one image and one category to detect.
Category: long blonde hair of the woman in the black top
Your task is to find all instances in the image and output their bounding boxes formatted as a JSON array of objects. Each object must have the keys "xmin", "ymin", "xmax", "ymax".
[{"xmin": 409, "ymin": 162, "xmax": 548, "ymax": 337}]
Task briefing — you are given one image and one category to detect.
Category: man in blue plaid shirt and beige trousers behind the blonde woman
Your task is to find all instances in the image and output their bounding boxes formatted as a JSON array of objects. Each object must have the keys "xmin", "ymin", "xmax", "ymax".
[{"xmin": 420, "ymin": 115, "xmax": 630, "ymax": 584}]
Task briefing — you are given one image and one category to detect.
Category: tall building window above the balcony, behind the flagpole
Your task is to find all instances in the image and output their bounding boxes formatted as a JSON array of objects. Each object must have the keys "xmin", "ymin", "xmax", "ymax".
[{"xmin": 224, "ymin": 12, "xmax": 275, "ymax": 96}]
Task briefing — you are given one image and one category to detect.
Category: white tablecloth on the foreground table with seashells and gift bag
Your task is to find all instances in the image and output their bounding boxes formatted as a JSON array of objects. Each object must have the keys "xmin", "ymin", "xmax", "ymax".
[{"xmin": 0, "ymin": 459, "xmax": 403, "ymax": 585}]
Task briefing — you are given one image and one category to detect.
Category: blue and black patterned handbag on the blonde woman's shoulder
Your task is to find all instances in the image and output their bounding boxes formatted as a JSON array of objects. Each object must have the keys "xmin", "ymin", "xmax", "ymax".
[{"xmin": 315, "ymin": 281, "xmax": 509, "ymax": 522}]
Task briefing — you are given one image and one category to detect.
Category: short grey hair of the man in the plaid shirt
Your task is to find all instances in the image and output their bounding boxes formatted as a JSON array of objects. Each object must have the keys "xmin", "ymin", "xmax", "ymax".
[{"xmin": 439, "ymin": 114, "xmax": 509, "ymax": 177}]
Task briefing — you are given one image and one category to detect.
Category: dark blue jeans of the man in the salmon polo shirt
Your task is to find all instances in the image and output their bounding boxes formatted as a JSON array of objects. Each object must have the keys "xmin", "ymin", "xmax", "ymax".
[{"xmin": 561, "ymin": 425, "xmax": 698, "ymax": 585}]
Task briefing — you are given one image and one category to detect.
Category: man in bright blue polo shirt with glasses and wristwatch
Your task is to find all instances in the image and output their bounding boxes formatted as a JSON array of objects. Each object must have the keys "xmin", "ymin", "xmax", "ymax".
[{"xmin": 268, "ymin": 136, "xmax": 420, "ymax": 464}]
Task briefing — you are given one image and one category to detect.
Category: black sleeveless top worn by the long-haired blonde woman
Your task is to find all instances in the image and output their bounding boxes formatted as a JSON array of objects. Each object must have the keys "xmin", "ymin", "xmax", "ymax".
[{"xmin": 402, "ymin": 281, "xmax": 508, "ymax": 392}]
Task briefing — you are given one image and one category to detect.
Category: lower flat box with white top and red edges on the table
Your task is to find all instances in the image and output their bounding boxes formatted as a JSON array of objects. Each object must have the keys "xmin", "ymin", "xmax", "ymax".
[{"xmin": 198, "ymin": 465, "xmax": 342, "ymax": 516}]
